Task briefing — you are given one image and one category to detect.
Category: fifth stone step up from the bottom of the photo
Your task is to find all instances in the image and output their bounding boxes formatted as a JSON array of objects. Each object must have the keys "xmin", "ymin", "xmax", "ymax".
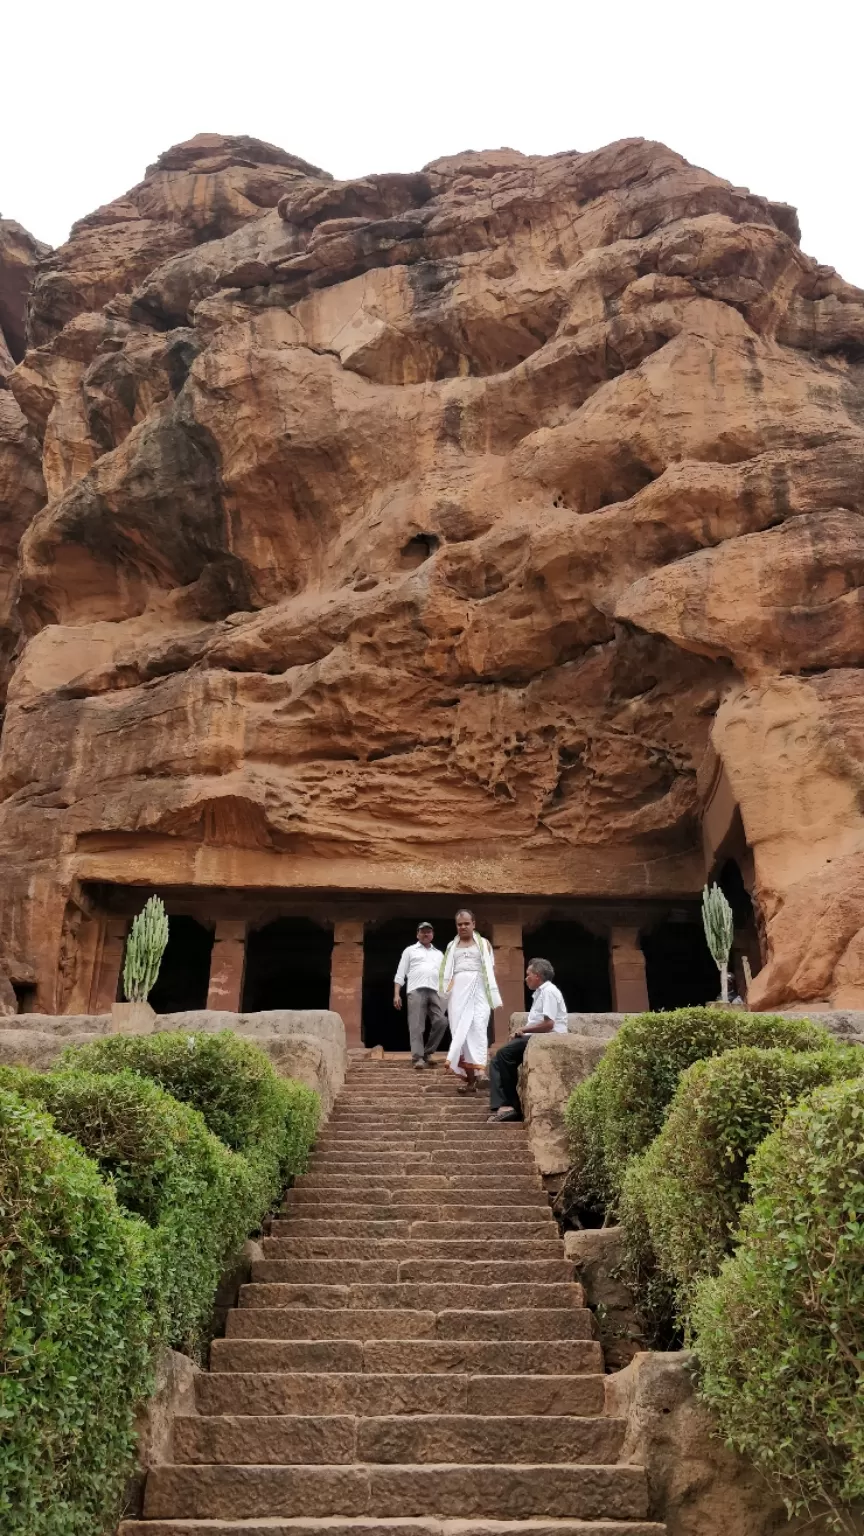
[{"xmin": 211, "ymin": 1338, "xmax": 603, "ymax": 1378}]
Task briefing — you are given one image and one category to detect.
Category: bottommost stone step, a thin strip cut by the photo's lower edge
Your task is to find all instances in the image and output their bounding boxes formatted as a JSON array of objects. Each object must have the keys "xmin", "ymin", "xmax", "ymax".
[{"xmin": 117, "ymin": 1516, "xmax": 666, "ymax": 1536}]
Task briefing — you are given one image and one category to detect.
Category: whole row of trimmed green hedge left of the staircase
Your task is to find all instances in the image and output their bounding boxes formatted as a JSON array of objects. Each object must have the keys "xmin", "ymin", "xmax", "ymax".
[{"xmin": 0, "ymin": 1032, "xmax": 320, "ymax": 1536}]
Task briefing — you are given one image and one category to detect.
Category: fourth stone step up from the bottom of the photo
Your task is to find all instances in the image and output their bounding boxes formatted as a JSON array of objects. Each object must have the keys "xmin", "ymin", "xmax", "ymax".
[{"xmin": 195, "ymin": 1372, "xmax": 604, "ymax": 1418}]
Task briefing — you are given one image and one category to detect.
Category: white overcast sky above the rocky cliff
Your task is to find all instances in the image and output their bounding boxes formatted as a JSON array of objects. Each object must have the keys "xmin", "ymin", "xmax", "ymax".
[{"xmin": 0, "ymin": 0, "xmax": 864, "ymax": 287}]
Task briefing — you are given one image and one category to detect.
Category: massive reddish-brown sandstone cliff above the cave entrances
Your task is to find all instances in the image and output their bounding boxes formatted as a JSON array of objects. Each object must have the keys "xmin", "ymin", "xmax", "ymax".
[{"xmin": 0, "ymin": 135, "xmax": 864, "ymax": 1009}]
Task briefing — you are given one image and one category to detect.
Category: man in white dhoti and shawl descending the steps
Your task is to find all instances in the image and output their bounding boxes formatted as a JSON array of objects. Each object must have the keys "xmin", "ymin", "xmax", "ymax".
[{"xmin": 438, "ymin": 906, "xmax": 501, "ymax": 1094}]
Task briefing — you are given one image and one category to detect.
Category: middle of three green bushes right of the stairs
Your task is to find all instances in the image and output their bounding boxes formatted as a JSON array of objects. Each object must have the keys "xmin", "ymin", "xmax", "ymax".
[{"xmin": 621, "ymin": 1046, "xmax": 864, "ymax": 1309}]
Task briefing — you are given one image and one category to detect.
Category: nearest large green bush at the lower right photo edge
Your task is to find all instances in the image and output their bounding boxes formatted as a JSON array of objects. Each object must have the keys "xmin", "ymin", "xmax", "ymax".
[{"xmin": 692, "ymin": 1078, "xmax": 864, "ymax": 1508}]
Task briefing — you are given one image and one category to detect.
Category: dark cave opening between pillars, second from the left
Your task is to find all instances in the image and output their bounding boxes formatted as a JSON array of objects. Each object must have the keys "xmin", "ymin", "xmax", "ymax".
[{"xmin": 241, "ymin": 917, "xmax": 334, "ymax": 1014}]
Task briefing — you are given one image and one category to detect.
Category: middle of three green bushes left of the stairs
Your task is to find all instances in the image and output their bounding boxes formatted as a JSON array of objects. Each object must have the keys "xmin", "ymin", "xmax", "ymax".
[{"xmin": 0, "ymin": 1068, "xmax": 253, "ymax": 1355}]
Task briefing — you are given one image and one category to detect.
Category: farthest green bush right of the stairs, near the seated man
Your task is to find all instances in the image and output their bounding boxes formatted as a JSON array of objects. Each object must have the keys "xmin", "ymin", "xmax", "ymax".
[{"xmin": 566, "ymin": 1008, "xmax": 830, "ymax": 1212}]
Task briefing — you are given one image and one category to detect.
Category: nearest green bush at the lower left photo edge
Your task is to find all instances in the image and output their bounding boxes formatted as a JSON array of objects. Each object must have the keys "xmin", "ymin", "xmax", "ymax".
[{"xmin": 0, "ymin": 1089, "xmax": 151, "ymax": 1536}]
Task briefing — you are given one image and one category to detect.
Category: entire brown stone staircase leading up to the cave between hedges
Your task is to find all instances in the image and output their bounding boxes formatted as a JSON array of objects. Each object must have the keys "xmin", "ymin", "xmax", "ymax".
[{"xmin": 120, "ymin": 1057, "xmax": 664, "ymax": 1536}]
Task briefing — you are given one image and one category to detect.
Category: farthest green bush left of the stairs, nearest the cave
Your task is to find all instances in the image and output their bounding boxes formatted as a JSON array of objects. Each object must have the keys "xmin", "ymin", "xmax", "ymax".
[{"xmin": 61, "ymin": 1029, "xmax": 320, "ymax": 1217}]
